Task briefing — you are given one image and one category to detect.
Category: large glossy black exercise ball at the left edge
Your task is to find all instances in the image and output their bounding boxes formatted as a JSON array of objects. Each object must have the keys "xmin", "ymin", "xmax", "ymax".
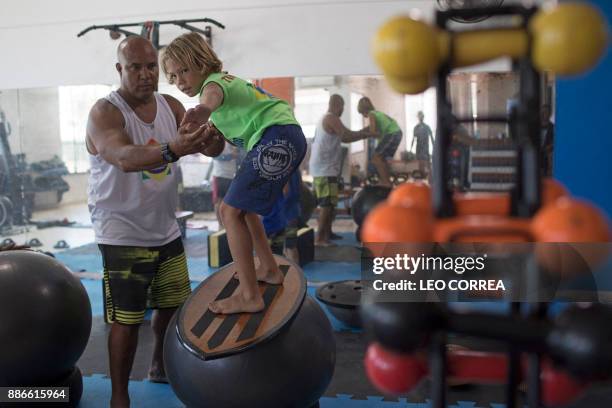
[{"xmin": 0, "ymin": 251, "xmax": 91, "ymax": 386}]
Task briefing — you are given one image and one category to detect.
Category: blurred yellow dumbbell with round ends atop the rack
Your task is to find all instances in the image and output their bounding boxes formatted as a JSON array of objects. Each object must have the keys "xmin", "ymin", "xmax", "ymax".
[{"xmin": 372, "ymin": 3, "xmax": 608, "ymax": 94}]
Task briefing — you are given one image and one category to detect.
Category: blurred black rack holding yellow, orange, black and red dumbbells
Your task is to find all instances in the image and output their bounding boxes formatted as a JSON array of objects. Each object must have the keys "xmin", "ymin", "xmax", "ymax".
[{"xmin": 363, "ymin": 3, "xmax": 612, "ymax": 408}]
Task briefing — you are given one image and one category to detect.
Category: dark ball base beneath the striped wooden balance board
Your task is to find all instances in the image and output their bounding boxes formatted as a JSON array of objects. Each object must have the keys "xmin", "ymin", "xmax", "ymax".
[{"xmin": 164, "ymin": 296, "xmax": 336, "ymax": 408}]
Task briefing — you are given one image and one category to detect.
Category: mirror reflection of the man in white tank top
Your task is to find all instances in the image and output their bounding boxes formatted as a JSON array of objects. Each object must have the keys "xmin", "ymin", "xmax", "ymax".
[{"xmin": 309, "ymin": 94, "xmax": 376, "ymax": 246}]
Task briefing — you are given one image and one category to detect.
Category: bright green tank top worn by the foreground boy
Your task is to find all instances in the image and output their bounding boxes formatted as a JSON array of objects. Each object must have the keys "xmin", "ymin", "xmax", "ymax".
[{"xmin": 200, "ymin": 72, "xmax": 299, "ymax": 151}]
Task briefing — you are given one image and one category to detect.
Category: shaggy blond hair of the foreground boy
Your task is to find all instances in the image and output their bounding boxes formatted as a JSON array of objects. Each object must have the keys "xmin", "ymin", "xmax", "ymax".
[{"xmin": 160, "ymin": 33, "xmax": 223, "ymax": 84}]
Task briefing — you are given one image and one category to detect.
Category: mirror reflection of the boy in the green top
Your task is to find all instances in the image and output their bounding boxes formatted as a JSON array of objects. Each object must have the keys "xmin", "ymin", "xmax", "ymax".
[{"xmin": 357, "ymin": 96, "xmax": 402, "ymax": 187}]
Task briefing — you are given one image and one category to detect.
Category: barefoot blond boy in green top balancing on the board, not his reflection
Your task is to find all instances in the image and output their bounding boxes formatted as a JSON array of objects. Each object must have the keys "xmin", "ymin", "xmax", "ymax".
[{"xmin": 161, "ymin": 33, "xmax": 306, "ymax": 314}]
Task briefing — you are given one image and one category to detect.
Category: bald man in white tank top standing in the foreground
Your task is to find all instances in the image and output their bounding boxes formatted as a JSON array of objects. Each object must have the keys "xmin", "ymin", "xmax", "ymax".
[{"xmin": 86, "ymin": 36, "xmax": 224, "ymax": 407}]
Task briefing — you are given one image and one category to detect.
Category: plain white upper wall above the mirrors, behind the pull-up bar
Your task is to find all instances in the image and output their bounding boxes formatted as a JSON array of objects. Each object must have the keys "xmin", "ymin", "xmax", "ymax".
[{"xmin": 0, "ymin": 0, "xmax": 435, "ymax": 89}]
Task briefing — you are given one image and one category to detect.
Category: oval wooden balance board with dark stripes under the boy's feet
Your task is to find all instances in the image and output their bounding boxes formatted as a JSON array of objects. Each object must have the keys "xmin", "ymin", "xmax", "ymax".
[{"xmin": 177, "ymin": 255, "xmax": 306, "ymax": 360}]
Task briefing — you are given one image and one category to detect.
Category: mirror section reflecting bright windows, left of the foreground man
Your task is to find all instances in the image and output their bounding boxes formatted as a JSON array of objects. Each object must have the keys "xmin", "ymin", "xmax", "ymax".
[{"xmin": 0, "ymin": 86, "xmax": 98, "ymax": 258}]
